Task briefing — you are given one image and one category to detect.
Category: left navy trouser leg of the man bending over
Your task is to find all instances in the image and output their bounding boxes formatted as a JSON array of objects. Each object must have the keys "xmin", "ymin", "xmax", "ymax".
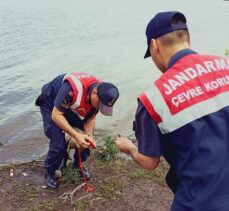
[{"xmin": 41, "ymin": 107, "xmax": 67, "ymax": 175}]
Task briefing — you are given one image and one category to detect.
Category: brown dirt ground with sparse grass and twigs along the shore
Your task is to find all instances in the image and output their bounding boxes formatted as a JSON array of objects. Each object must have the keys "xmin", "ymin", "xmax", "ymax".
[{"xmin": 0, "ymin": 155, "xmax": 173, "ymax": 211}]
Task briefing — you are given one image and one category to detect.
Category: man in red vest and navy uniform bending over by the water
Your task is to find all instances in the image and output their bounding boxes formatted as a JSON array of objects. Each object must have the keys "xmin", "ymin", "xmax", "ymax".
[{"xmin": 36, "ymin": 72, "xmax": 119, "ymax": 188}]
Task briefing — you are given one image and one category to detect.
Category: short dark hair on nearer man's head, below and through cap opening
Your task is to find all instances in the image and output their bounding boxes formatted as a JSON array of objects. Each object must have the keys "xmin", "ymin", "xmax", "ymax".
[{"xmin": 158, "ymin": 15, "xmax": 190, "ymax": 46}]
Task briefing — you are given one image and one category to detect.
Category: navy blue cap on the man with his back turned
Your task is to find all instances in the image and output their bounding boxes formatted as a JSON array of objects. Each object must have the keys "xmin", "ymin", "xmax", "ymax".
[{"xmin": 144, "ymin": 11, "xmax": 188, "ymax": 58}]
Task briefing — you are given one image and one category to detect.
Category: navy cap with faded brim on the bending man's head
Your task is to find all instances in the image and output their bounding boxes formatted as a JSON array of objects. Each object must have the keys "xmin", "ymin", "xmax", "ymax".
[{"xmin": 97, "ymin": 82, "xmax": 119, "ymax": 116}]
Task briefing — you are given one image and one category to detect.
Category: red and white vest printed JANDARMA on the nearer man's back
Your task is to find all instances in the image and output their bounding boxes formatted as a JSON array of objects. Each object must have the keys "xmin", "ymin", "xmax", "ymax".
[{"xmin": 139, "ymin": 54, "xmax": 229, "ymax": 134}]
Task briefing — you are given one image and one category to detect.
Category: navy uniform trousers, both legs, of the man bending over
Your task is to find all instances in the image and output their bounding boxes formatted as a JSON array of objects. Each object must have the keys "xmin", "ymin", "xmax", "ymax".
[{"xmin": 40, "ymin": 104, "xmax": 90, "ymax": 175}]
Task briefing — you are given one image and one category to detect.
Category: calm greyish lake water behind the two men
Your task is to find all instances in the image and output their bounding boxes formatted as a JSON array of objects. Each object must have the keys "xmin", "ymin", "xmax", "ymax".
[{"xmin": 0, "ymin": 0, "xmax": 229, "ymax": 164}]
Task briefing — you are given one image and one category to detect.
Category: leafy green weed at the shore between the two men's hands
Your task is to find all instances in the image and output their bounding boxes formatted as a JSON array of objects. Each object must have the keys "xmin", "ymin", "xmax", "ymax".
[{"xmin": 95, "ymin": 136, "xmax": 118, "ymax": 161}]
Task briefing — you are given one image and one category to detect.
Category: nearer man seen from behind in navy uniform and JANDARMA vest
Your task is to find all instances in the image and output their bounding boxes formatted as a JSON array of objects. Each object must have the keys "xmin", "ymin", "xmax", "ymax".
[{"xmin": 116, "ymin": 12, "xmax": 229, "ymax": 211}]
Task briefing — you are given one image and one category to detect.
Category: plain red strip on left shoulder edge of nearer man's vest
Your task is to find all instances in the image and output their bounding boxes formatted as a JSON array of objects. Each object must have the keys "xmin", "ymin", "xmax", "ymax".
[{"xmin": 139, "ymin": 93, "xmax": 162, "ymax": 124}]
